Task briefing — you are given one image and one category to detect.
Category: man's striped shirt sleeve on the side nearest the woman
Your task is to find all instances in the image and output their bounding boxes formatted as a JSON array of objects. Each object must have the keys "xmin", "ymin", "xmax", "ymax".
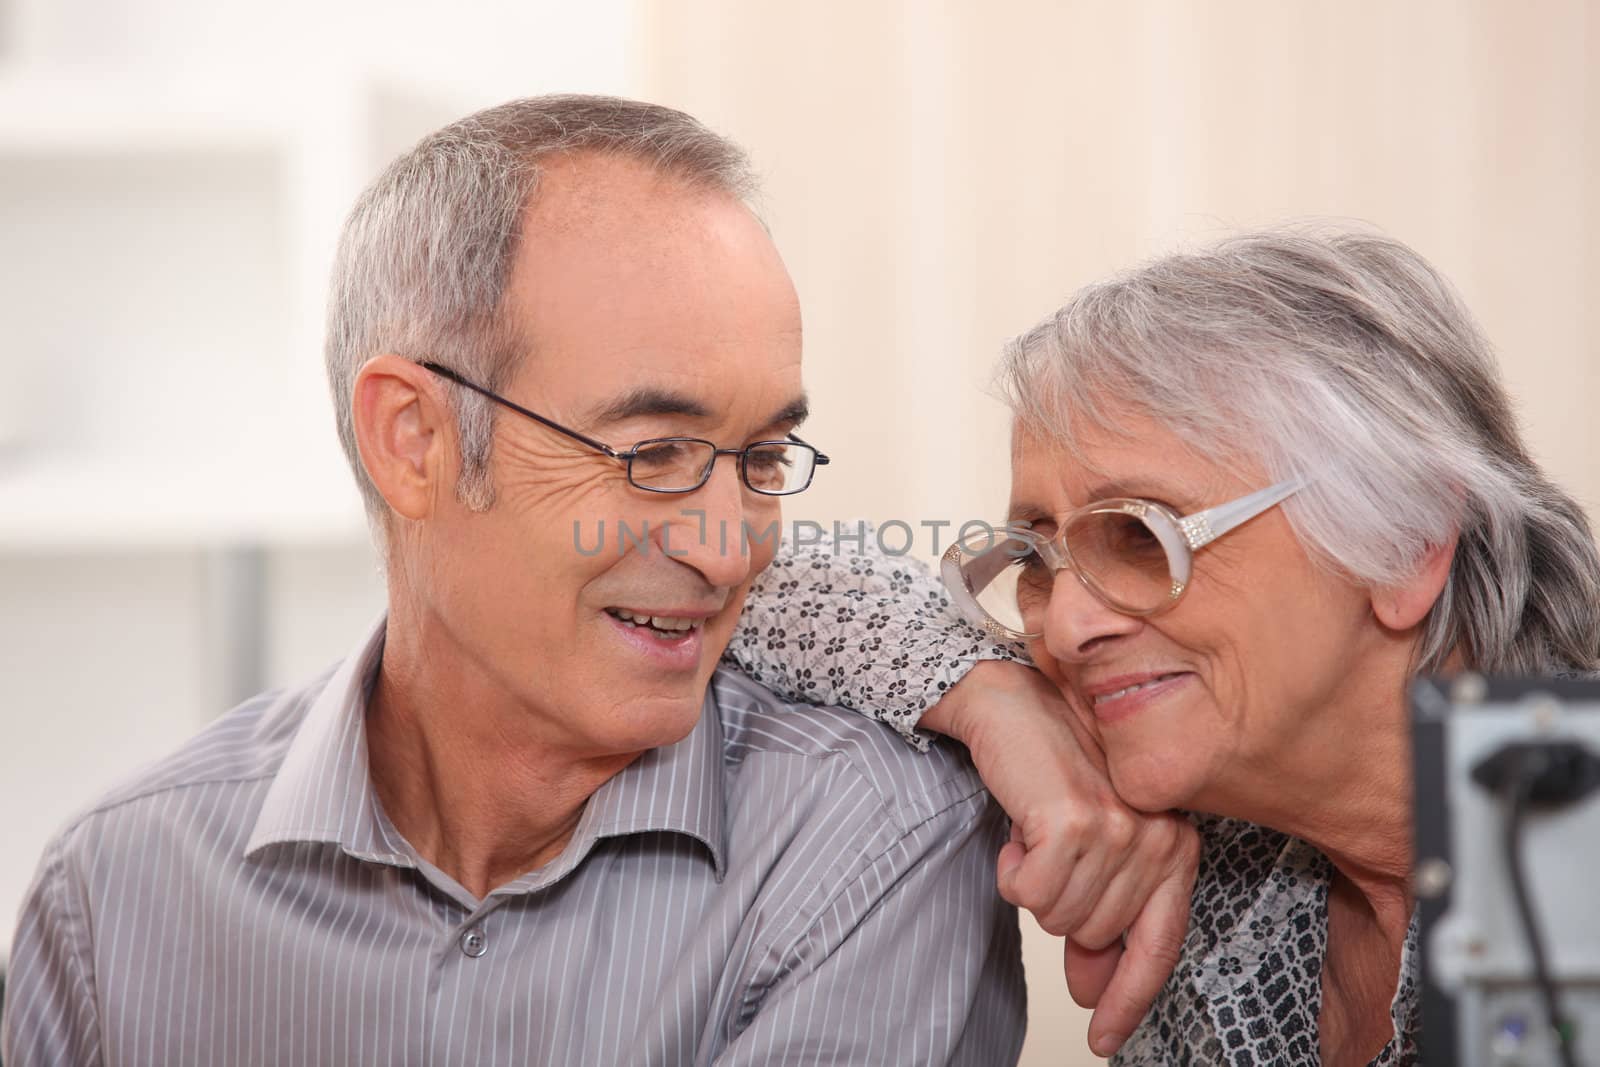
[{"xmin": 710, "ymin": 780, "xmax": 1027, "ymax": 1067}]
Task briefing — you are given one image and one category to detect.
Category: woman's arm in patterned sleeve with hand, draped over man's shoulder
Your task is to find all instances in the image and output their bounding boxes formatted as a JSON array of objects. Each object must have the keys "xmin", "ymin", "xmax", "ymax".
[{"xmin": 726, "ymin": 530, "xmax": 1200, "ymax": 1054}]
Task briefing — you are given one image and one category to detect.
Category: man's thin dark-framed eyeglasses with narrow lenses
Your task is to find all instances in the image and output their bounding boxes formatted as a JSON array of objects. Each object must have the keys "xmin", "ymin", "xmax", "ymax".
[{"xmin": 419, "ymin": 363, "xmax": 829, "ymax": 496}]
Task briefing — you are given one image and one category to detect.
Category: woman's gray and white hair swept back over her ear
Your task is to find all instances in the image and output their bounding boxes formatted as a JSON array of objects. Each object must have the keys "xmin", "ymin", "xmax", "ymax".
[{"xmin": 1000, "ymin": 227, "xmax": 1600, "ymax": 673}]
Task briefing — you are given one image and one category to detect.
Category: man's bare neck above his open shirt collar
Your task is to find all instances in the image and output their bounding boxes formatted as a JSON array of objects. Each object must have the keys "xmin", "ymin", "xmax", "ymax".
[{"xmin": 366, "ymin": 622, "xmax": 638, "ymax": 899}]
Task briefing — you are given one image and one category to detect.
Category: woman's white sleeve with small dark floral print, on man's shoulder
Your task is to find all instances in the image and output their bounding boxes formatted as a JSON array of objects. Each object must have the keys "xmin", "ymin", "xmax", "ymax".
[{"xmin": 723, "ymin": 523, "xmax": 1027, "ymax": 750}]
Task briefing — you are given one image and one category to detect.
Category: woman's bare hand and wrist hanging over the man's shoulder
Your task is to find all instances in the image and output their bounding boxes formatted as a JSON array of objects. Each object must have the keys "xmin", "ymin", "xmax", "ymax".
[{"xmin": 920, "ymin": 661, "xmax": 1200, "ymax": 1056}]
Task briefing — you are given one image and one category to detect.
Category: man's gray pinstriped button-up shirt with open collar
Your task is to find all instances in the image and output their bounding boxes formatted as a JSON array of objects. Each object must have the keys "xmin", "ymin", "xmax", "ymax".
[{"xmin": 0, "ymin": 627, "xmax": 1024, "ymax": 1067}]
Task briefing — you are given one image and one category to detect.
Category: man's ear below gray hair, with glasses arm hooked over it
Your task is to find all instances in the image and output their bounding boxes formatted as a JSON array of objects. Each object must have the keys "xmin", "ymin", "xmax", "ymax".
[{"xmin": 350, "ymin": 355, "xmax": 453, "ymax": 520}]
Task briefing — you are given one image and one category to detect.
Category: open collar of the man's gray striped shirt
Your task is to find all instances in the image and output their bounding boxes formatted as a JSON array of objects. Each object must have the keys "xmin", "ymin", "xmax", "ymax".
[{"xmin": 245, "ymin": 617, "xmax": 726, "ymax": 893}]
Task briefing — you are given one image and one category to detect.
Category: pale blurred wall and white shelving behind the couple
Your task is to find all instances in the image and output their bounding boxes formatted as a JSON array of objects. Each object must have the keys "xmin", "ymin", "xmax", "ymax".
[{"xmin": 0, "ymin": 0, "xmax": 1600, "ymax": 1067}]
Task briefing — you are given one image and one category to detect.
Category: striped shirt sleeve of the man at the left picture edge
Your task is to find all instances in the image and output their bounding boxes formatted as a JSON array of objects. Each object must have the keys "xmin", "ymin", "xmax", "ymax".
[{"xmin": 0, "ymin": 841, "xmax": 101, "ymax": 1067}]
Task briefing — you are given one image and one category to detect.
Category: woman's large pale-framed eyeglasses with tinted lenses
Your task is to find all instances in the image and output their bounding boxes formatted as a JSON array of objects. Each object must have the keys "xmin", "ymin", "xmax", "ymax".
[{"xmin": 941, "ymin": 478, "xmax": 1306, "ymax": 640}]
